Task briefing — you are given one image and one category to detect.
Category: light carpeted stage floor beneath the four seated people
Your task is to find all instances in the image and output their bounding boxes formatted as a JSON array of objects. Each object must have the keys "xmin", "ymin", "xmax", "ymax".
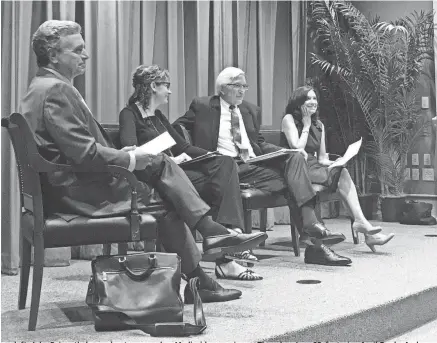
[{"xmin": 1, "ymin": 218, "xmax": 437, "ymax": 342}]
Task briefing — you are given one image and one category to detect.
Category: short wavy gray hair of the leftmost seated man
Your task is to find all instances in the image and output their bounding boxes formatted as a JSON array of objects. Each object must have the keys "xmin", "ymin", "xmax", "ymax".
[{"xmin": 32, "ymin": 20, "xmax": 82, "ymax": 67}]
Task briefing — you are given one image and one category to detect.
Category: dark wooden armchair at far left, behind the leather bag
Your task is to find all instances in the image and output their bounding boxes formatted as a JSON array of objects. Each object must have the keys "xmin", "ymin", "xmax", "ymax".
[{"xmin": 1, "ymin": 113, "xmax": 161, "ymax": 331}]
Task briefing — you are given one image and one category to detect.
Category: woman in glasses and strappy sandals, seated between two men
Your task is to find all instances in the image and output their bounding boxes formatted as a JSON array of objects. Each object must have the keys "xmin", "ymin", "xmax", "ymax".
[{"xmin": 119, "ymin": 65, "xmax": 262, "ymax": 281}]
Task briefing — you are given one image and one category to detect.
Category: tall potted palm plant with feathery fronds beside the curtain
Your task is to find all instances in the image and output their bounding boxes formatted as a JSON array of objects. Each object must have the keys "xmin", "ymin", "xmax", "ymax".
[{"xmin": 309, "ymin": 1, "xmax": 434, "ymax": 221}]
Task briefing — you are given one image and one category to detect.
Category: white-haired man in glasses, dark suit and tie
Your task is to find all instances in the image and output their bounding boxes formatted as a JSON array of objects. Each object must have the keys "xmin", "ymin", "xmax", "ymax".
[{"xmin": 174, "ymin": 67, "xmax": 351, "ymax": 265}]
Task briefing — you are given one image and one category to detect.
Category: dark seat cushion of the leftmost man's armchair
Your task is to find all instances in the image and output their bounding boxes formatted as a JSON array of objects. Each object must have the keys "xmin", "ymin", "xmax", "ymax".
[{"xmin": 21, "ymin": 210, "xmax": 165, "ymax": 248}]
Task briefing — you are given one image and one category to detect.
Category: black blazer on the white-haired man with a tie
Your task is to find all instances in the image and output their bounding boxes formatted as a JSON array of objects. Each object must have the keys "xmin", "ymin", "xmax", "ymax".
[{"xmin": 173, "ymin": 95, "xmax": 281, "ymax": 156}]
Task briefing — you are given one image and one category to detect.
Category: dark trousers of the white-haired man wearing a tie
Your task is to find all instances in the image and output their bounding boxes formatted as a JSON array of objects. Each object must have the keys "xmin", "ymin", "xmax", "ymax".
[{"xmin": 238, "ymin": 153, "xmax": 316, "ymax": 228}]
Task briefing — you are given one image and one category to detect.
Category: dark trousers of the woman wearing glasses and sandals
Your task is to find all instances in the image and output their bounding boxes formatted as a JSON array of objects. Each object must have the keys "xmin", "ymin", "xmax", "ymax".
[{"xmin": 182, "ymin": 156, "xmax": 244, "ymax": 228}]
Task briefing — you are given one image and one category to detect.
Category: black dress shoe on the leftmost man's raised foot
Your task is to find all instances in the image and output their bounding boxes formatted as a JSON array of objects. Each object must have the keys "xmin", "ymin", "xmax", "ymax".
[{"xmin": 202, "ymin": 232, "xmax": 267, "ymax": 262}]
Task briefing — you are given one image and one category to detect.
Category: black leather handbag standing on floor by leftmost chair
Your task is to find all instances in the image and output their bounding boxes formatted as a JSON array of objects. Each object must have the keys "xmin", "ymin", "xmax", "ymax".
[{"xmin": 86, "ymin": 252, "xmax": 206, "ymax": 336}]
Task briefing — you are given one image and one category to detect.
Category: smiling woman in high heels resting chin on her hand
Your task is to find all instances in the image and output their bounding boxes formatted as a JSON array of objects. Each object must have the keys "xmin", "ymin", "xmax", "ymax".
[{"xmin": 281, "ymin": 86, "xmax": 394, "ymax": 252}]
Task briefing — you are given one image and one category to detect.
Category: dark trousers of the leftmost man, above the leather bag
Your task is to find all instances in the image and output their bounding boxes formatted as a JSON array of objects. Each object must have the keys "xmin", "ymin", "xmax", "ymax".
[{"xmin": 135, "ymin": 154, "xmax": 210, "ymax": 273}]
